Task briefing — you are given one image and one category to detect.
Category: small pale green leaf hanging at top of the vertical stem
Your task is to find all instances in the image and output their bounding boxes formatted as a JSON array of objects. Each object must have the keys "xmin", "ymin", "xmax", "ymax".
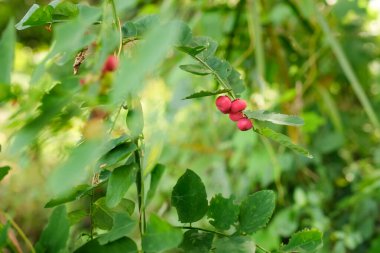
[{"xmin": 126, "ymin": 99, "xmax": 144, "ymax": 138}]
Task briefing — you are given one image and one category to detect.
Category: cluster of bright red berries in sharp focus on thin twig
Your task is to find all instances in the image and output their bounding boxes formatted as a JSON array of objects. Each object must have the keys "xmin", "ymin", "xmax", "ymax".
[{"xmin": 215, "ymin": 96, "xmax": 253, "ymax": 131}]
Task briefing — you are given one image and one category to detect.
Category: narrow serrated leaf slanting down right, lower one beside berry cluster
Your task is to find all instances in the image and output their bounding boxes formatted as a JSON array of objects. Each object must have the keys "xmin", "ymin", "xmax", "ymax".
[{"xmin": 253, "ymin": 127, "xmax": 313, "ymax": 158}]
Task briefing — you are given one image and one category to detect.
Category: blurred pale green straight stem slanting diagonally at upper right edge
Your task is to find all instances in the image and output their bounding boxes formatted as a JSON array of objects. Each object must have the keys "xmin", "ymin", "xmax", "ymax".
[{"xmin": 313, "ymin": 4, "xmax": 380, "ymax": 129}]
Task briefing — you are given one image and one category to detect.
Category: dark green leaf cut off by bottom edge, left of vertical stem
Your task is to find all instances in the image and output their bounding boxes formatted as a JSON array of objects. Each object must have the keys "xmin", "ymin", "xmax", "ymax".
[{"xmin": 74, "ymin": 237, "xmax": 138, "ymax": 253}]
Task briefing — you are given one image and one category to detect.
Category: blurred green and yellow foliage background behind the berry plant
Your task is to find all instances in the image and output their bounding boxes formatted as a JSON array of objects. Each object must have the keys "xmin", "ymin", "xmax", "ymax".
[{"xmin": 0, "ymin": 0, "xmax": 380, "ymax": 253}]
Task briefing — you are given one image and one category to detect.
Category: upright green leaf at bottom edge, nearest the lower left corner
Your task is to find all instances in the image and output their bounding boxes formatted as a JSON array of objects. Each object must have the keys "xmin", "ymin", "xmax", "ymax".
[{"xmin": 36, "ymin": 205, "xmax": 70, "ymax": 252}]
